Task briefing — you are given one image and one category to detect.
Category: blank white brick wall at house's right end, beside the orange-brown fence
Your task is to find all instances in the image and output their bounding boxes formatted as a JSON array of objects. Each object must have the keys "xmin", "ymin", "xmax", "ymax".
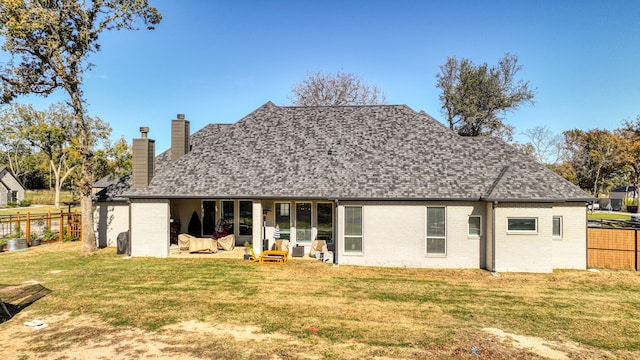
[{"xmin": 552, "ymin": 203, "xmax": 587, "ymax": 269}]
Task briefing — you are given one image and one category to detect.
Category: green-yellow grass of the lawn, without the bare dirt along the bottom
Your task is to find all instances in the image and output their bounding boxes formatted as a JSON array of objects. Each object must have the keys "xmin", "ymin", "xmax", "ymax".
[{"xmin": 0, "ymin": 243, "xmax": 640, "ymax": 359}]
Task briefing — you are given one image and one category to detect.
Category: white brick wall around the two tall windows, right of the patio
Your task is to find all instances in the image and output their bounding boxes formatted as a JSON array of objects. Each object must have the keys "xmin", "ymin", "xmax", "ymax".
[{"xmin": 336, "ymin": 202, "xmax": 485, "ymax": 268}]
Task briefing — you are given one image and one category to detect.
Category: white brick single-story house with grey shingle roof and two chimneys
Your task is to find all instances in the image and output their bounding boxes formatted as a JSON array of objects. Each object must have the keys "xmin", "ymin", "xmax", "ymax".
[{"xmin": 97, "ymin": 102, "xmax": 592, "ymax": 272}]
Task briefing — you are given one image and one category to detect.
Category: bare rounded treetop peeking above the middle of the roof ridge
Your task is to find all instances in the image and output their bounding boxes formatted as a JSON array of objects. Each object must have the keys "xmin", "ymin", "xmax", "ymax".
[{"xmin": 290, "ymin": 71, "xmax": 386, "ymax": 106}]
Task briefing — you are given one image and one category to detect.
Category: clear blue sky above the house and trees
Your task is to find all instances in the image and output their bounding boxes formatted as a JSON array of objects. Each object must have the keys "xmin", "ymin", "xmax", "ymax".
[{"xmin": 5, "ymin": 0, "xmax": 640, "ymax": 153}]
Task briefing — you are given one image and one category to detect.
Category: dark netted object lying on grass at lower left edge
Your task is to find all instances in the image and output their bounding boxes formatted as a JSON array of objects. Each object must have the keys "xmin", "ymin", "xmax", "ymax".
[{"xmin": 0, "ymin": 282, "xmax": 51, "ymax": 324}]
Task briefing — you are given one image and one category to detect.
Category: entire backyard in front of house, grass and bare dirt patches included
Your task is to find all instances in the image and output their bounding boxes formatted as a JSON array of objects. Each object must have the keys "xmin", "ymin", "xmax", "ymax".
[{"xmin": 0, "ymin": 243, "xmax": 640, "ymax": 359}]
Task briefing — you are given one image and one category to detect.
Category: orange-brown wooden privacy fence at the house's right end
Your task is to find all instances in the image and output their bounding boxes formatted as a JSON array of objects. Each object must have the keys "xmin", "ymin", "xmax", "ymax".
[{"xmin": 587, "ymin": 228, "xmax": 640, "ymax": 271}]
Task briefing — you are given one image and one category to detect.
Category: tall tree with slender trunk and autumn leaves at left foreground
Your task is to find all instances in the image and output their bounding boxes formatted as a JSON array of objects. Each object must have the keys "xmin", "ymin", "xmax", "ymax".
[{"xmin": 0, "ymin": 0, "xmax": 162, "ymax": 253}]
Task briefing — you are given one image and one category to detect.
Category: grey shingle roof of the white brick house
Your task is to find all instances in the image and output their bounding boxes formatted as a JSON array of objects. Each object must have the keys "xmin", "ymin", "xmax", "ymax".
[{"xmin": 120, "ymin": 102, "xmax": 591, "ymax": 201}]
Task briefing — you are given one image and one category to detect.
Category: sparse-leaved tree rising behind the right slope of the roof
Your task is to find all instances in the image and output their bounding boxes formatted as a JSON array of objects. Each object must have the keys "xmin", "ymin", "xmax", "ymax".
[{"xmin": 436, "ymin": 54, "xmax": 535, "ymax": 137}]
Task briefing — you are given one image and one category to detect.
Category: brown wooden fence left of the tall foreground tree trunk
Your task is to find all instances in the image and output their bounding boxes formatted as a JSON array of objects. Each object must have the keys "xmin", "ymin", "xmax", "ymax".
[{"xmin": 0, "ymin": 210, "xmax": 82, "ymax": 242}]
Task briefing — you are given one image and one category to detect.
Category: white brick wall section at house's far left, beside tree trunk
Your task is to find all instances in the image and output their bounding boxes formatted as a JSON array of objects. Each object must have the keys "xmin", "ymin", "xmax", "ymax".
[{"xmin": 94, "ymin": 202, "xmax": 129, "ymax": 248}]
